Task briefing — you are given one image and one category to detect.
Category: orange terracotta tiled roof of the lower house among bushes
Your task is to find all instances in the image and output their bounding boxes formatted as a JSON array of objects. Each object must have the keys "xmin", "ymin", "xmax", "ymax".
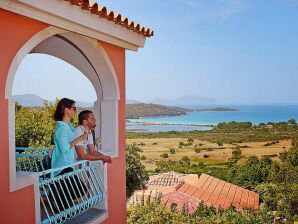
[{"xmin": 130, "ymin": 172, "xmax": 259, "ymax": 213}]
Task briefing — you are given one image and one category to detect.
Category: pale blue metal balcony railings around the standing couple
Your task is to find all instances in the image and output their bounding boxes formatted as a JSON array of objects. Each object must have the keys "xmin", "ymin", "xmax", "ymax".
[{"xmin": 16, "ymin": 148, "xmax": 107, "ymax": 224}]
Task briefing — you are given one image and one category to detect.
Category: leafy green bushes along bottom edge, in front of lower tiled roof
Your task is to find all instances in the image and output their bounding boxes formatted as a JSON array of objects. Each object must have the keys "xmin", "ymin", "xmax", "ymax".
[{"xmin": 127, "ymin": 202, "xmax": 273, "ymax": 224}]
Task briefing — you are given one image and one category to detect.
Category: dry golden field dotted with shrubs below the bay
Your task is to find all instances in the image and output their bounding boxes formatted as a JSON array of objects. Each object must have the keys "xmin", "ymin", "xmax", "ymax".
[{"xmin": 126, "ymin": 138, "xmax": 292, "ymax": 171}]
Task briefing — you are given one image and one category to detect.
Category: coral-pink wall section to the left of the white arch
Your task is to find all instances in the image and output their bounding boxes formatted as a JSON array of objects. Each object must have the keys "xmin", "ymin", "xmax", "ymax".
[{"xmin": 0, "ymin": 9, "xmax": 48, "ymax": 224}]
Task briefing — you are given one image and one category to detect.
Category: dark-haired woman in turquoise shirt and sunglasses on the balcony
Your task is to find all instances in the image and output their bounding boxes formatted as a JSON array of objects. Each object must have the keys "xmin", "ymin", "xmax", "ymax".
[{"xmin": 49, "ymin": 98, "xmax": 88, "ymax": 211}]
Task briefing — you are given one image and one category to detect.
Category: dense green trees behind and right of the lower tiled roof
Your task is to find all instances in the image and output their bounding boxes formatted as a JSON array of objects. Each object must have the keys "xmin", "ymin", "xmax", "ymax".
[{"xmin": 148, "ymin": 128, "xmax": 298, "ymax": 223}]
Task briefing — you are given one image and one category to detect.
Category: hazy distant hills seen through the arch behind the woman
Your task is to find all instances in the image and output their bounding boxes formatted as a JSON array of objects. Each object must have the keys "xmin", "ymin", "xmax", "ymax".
[{"xmin": 13, "ymin": 94, "xmax": 94, "ymax": 108}]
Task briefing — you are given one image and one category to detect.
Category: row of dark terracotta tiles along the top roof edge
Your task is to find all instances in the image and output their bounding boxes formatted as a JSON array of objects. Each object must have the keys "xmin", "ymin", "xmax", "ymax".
[{"xmin": 61, "ymin": 0, "xmax": 154, "ymax": 37}]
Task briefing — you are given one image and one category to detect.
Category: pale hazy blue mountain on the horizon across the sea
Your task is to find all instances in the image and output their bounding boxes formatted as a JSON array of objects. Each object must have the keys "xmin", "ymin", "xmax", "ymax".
[{"xmin": 149, "ymin": 95, "xmax": 216, "ymax": 106}]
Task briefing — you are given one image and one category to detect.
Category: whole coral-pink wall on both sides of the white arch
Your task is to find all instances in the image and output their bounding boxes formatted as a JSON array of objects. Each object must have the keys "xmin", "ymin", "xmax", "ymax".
[{"xmin": 0, "ymin": 9, "xmax": 126, "ymax": 224}]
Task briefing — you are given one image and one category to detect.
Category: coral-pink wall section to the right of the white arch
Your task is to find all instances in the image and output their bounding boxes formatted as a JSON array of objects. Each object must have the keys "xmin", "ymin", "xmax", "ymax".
[{"xmin": 100, "ymin": 42, "xmax": 126, "ymax": 224}]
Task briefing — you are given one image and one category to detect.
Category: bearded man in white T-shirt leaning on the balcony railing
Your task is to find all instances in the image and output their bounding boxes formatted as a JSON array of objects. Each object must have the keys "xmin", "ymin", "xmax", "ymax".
[{"xmin": 75, "ymin": 110, "xmax": 112, "ymax": 163}]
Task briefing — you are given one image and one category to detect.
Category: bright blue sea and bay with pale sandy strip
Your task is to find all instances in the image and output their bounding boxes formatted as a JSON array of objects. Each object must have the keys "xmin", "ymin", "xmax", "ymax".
[{"xmin": 126, "ymin": 104, "xmax": 298, "ymax": 132}]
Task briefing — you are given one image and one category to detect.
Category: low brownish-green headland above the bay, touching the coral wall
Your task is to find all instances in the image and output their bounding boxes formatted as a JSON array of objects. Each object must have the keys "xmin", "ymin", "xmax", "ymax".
[{"xmin": 126, "ymin": 103, "xmax": 191, "ymax": 119}]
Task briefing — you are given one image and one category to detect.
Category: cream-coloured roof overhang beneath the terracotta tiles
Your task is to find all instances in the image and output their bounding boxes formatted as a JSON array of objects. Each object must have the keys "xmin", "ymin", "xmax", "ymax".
[{"xmin": 0, "ymin": 0, "xmax": 151, "ymax": 51}]
